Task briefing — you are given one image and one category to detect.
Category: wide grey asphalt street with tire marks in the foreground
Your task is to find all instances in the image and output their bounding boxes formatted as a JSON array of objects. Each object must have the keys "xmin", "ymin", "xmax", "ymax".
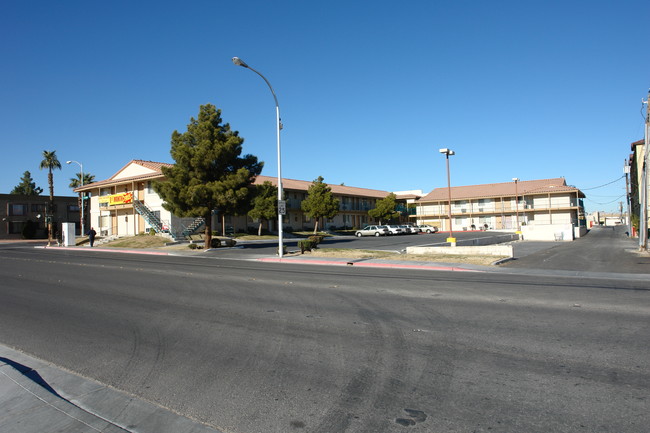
[{"xmin": 0, "ymin": 241, "xmax": 650, "ymax": 433}]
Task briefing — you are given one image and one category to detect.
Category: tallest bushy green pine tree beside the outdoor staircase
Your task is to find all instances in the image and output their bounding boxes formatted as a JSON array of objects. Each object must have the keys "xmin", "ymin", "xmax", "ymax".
[{"xmin": 154, "ymin": 104, "xmax": 264, "ymax": 248}]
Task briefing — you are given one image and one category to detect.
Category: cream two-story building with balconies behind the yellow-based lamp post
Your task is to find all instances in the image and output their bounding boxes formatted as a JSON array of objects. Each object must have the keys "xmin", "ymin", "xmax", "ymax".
[{"xmin": 411, "ymin": 178, "xmax": 585, "ymax": 238}]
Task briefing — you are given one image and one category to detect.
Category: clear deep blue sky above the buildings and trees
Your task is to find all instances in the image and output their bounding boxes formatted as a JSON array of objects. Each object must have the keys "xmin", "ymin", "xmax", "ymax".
[{"xmin": 0, "ymin": 0, "xmax": 650, "ymax": 211}]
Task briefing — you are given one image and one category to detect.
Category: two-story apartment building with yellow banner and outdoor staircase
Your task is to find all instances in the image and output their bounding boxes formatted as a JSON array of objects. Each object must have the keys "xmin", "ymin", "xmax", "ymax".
[{"xmin": 75, "ymin": 160, "xmax": 389, "ymax": 237}]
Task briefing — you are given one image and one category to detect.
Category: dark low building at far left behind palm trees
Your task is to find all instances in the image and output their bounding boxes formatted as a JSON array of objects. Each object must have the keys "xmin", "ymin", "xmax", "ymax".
[{"xmin": 0, "ymin": 194, "xmax": 81, "ymax": 239}]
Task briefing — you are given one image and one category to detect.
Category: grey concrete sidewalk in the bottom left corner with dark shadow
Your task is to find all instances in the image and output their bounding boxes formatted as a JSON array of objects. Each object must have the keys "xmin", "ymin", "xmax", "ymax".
[{"xmin": 0, "ymin": 345, "xmax": 220, "ymax": 433}]
